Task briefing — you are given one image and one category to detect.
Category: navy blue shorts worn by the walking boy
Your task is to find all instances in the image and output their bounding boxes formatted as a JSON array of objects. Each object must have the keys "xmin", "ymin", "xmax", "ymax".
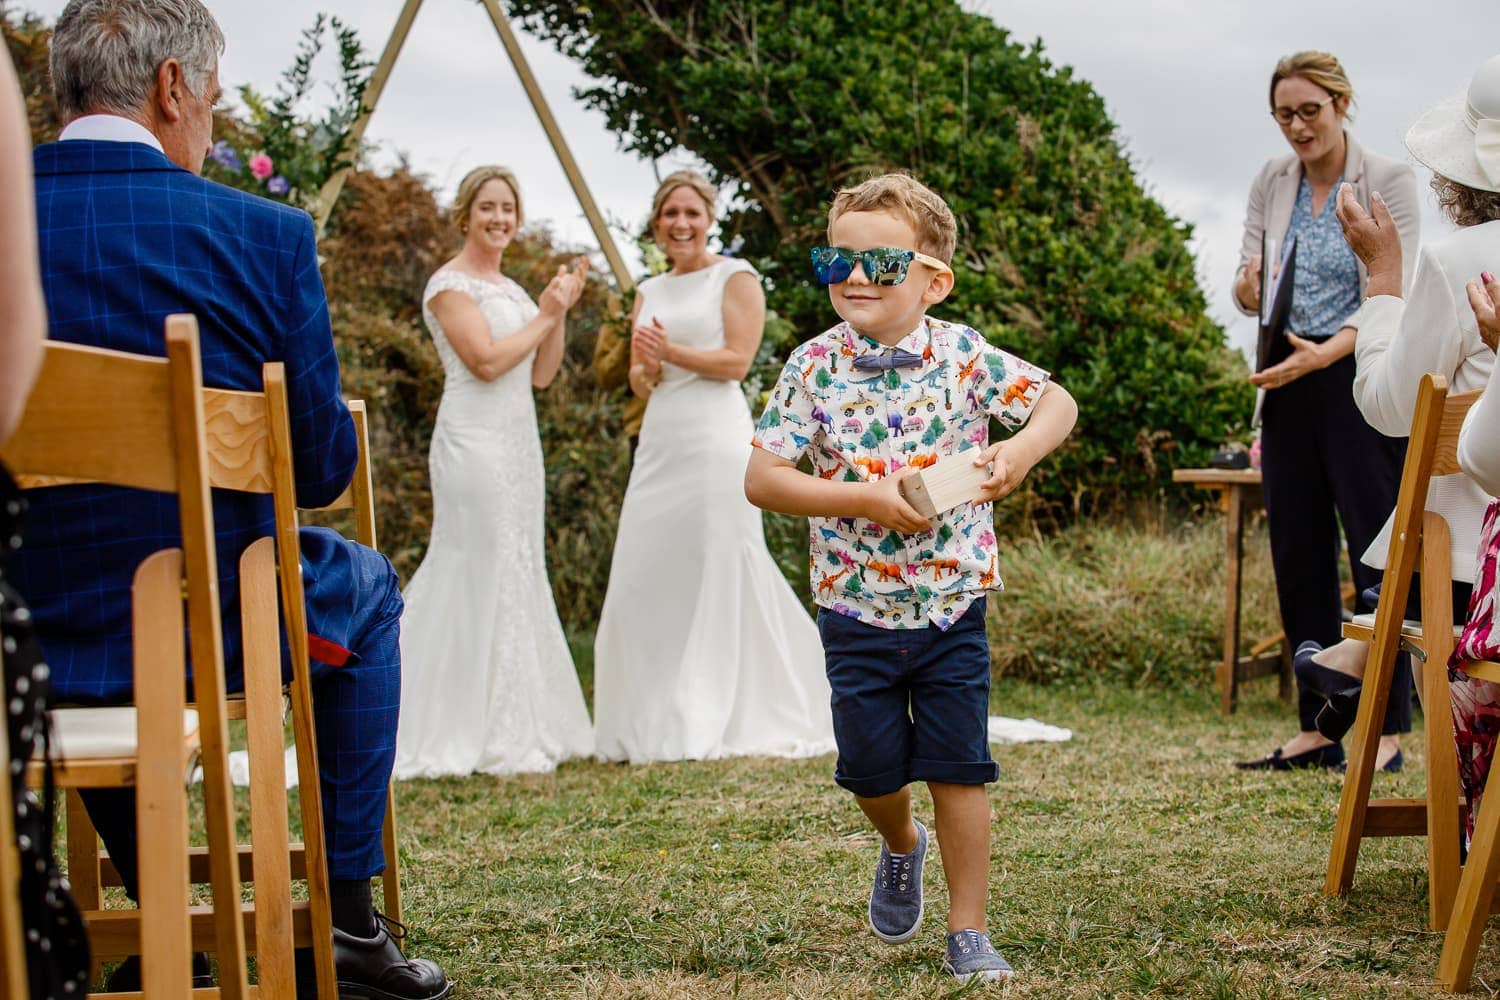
[{"xmin": 818, "ymin": 595, "xmax": 1001, "ymax": 798}]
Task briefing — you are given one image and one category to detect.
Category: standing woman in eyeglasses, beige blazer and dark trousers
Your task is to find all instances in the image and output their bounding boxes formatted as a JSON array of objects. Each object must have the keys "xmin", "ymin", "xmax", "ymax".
[{"xmin": 1233, "ymin": 52, "xmax": 1419, "ymax": 771}]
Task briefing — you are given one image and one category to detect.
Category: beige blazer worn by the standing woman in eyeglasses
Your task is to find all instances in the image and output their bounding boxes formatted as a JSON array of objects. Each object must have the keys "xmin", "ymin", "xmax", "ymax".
[{"xmin": 1230, "ymin": 132, "xmax": 1422, "ymax": 333}]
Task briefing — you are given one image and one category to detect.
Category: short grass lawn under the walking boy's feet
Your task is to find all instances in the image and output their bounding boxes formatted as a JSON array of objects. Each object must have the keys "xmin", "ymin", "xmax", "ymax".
[{"xmin": 381, "ymin": 681, "xmax": 1500, "ymax": 999}]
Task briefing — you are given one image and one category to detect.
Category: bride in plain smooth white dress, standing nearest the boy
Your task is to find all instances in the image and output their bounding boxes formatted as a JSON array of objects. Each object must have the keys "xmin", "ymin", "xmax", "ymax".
[{"xmin": 594, "ymin": 171, "xmax": 834, "ymax": 763}]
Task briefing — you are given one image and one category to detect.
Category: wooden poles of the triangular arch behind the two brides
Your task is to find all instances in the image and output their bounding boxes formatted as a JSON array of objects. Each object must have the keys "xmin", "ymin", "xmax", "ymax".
[{"xmin": 318, "ymin": 0, "xmax": 635, "ymax": 291}]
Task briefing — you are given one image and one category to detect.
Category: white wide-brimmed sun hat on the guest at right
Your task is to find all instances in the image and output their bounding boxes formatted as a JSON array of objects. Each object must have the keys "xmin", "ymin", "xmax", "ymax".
[{"xmin": 1406, "ymin": 55, "xmax": 1500, "ymax": 192}]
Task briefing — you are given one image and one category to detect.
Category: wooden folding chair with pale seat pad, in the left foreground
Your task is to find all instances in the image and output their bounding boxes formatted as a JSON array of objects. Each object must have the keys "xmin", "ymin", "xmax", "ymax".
[{"xmin": 0, "ymin": 315, "xmax": 253, "ymax": 1000}]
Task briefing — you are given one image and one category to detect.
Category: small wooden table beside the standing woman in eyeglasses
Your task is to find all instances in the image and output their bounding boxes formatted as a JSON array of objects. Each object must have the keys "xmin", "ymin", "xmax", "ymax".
[{"xmin": 1172, "ymin": 469, "xmax": 1293, "ymax": 715}]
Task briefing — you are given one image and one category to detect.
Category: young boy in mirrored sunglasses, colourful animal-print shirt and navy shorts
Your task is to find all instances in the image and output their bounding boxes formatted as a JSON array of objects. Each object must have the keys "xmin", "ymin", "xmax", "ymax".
[{"xmin": 746, "ymin": 174, "xmax": 1077, "ymax": 982}]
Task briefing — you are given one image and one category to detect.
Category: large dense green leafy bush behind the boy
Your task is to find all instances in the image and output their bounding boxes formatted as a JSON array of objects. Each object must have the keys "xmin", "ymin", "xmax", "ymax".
[{"xmin": 510, "ymin": 0, "xmax": 1251, "ymax": 513}]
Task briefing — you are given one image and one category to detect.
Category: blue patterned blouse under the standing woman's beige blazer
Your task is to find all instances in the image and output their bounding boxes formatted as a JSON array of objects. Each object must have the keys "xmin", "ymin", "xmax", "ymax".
[{"xmin": 1287, "ymin": 177, "xmax": 1359, "ymax": 340}]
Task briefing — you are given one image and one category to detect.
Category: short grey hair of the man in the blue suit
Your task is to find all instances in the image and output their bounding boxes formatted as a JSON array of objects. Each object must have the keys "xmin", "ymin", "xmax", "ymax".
[{"xmin": 51, "ymin": 0, "xmax": 224, "ymax": 120}]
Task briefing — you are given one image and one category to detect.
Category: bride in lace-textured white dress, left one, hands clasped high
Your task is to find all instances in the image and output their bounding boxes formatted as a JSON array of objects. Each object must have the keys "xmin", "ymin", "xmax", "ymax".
[{"xmin": 395, "ymin": 166, "xmax": 594, "ymax": 778}]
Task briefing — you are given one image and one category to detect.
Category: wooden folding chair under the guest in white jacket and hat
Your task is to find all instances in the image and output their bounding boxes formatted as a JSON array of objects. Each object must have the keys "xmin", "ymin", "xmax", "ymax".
[{"xmin": 1323, "ymin": 373, "xmax": 1479, "ymax": 931}]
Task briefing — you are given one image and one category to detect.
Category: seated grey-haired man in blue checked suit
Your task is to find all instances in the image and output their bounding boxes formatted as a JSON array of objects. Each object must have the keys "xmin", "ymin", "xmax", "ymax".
[{"xmin": 17, "ymin": 0, "xmax": 452, "ymax": 1000}]
